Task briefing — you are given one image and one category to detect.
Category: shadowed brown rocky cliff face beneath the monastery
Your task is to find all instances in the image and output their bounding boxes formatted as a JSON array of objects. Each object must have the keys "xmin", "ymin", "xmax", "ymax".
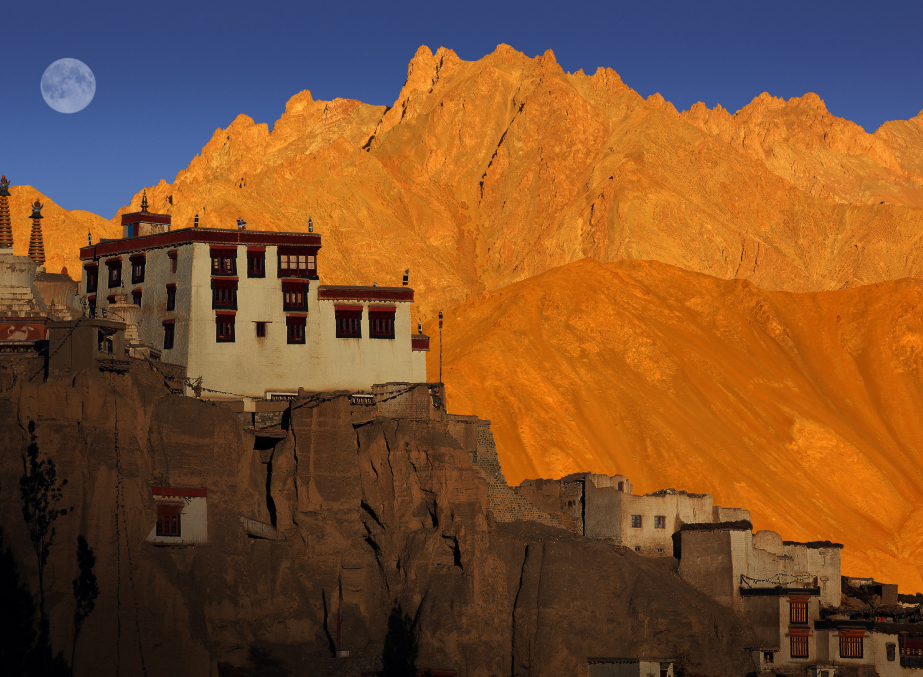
[{"xmin": 0, "ymin": 368, "xmax": 749, "ymax": 676}]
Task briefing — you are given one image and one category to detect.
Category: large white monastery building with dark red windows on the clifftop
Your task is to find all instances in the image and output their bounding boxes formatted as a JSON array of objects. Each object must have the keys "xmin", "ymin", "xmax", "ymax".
[{"xmin": 80, "ymin": 196, "xmax": 429, "ymax": 399}]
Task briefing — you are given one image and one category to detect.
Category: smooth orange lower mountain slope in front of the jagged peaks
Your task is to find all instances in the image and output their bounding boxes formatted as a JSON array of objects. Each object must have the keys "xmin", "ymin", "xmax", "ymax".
[{"xmin": 428, "ymin": 260, "xmax": 923, "ymax": 591}]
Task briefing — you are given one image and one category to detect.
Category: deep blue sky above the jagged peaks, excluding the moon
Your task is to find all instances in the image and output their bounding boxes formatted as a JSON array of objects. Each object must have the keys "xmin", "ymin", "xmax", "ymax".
[{"xmin": 0, "ymin": 0, "xmax": 923, "ymax": 218}]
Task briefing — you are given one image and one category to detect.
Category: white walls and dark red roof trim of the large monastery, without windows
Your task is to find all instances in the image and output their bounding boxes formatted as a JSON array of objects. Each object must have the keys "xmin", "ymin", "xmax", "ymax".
[{"xmin": 81, "ymin": 224, "xmax": 428, "ymax": 399}]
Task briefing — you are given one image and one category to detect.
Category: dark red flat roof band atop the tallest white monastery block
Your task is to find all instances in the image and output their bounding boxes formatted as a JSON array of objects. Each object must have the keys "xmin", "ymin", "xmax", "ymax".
[{"xmin": 80, "ymin": 228, "xmax": 321, "ymax": 261}]
